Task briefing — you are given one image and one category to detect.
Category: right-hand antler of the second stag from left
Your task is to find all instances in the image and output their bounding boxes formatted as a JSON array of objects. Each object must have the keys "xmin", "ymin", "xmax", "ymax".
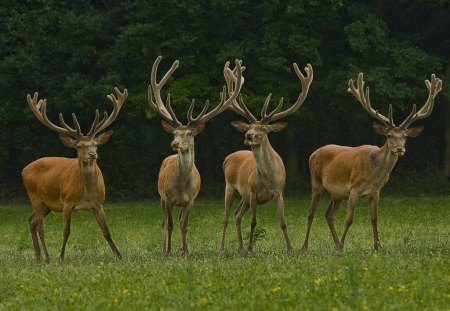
[{"xmin": 190, "ymin": 59, "xmax": 243, "ymax": 124}]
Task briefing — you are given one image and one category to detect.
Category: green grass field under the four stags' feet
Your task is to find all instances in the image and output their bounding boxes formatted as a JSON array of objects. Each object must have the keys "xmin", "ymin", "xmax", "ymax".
[{"xmin": 0, "ymin": 196, "xmax": 450, "ymax": 310}]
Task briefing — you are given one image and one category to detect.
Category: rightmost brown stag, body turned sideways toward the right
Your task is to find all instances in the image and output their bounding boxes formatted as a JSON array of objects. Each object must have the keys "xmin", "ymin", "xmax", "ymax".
[{"xmin": 302, "ymin": 73, "xmax": 442, "ymax": 251}]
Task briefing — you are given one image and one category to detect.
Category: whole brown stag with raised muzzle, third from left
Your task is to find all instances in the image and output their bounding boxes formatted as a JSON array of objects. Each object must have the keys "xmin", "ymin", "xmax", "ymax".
[{"xmin": 221, "ymin": 63, "xmax": 313, "ymax": 252}]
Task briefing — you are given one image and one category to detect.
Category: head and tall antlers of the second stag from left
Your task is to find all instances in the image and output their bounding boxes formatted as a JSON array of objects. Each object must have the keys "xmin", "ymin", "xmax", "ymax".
[{"xmin": 148, "ymin": 56, "xmax": 244, "ymax": 152}]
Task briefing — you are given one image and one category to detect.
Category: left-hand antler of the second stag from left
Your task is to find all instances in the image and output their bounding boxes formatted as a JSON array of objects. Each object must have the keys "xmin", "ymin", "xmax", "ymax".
[{"xmin": 148, "ymin": 56, "xmax": 181, "ymax": 125}]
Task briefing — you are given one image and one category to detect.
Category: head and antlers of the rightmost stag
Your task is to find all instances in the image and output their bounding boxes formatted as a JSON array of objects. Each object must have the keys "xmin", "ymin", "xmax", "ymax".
[{"xmin": 348, "ymin": 72, "xmax": 442, "ymax": 156}]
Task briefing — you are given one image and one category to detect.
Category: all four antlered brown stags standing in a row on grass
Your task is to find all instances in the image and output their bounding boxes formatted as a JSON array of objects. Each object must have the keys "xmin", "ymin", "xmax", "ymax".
[{"xmin": 22, "ymin": 56, "xmax": 442, "ymax": 261}]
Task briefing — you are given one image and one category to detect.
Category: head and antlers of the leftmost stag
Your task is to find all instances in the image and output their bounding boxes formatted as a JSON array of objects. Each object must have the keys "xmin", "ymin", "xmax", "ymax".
[{"xmin": 27, "ymin": 88, "xmax": 128, "ymax": 164}]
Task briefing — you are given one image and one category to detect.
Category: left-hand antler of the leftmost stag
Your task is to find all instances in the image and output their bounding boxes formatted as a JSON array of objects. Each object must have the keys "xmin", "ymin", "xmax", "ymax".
[{"xmin": 27, "ymin": 92, "xmax": 83, "ymax": 139}]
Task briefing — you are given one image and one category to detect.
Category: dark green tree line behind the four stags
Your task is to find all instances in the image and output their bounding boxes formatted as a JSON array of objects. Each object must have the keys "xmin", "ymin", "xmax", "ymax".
[{"xmin": 0, "ymin": 0, "xmax": 450, "ymax": 199}]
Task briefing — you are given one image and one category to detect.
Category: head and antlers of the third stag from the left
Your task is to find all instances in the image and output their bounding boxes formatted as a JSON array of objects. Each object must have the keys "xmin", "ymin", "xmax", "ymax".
[{"xmin": 224, "ymin": 63, "xmax": 313, "ymax": 146}]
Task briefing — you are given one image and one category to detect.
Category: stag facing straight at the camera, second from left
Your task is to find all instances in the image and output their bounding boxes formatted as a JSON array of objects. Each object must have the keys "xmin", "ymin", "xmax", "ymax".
[{"xmin": 148, "ymin": 56, "xmax": 244, "ymax": 256}]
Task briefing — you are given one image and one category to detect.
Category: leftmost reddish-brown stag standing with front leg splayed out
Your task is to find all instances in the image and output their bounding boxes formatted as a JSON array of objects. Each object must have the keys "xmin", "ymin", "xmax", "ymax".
[{"xmin": 22, "ymin": 88, "xmax": 128, "ymax": 262}]
